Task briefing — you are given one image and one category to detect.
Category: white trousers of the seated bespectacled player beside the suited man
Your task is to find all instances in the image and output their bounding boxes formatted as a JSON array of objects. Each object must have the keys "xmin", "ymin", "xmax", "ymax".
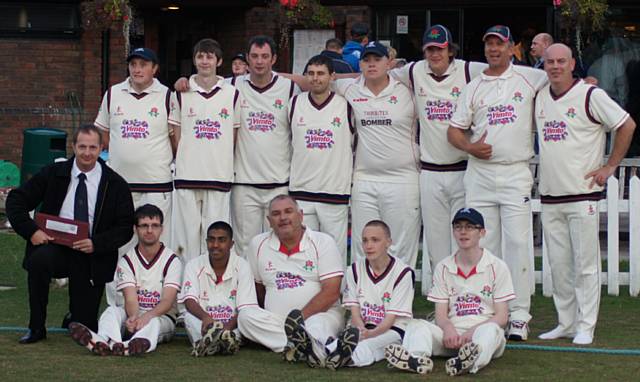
[{"xmin": 98, "ymin": 306, "xmax": 176, "ymax": 353}]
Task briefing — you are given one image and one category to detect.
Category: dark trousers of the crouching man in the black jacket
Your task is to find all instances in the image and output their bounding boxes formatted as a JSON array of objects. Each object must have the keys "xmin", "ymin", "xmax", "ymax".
[{"xmin": 25, "ymin": 244, "xmax": 104, "ymax": 332}]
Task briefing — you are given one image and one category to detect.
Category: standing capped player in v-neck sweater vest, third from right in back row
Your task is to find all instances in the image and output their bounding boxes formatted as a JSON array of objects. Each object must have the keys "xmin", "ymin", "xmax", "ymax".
[{"xmin": 389, "ymin": 24, "xmax": 487, "ymax": 295}]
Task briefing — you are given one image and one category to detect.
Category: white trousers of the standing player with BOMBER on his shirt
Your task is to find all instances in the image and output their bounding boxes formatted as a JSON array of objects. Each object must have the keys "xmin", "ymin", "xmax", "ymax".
[{"xmin": 351, "ymin": 180, "xmax": 420, "ymax": 269}]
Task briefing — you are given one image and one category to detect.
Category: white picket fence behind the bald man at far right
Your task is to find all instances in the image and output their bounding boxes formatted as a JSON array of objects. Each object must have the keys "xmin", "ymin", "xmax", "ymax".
[{"xmin": 532, "ymin": 158, "xmax": 640, "ymax": 297}]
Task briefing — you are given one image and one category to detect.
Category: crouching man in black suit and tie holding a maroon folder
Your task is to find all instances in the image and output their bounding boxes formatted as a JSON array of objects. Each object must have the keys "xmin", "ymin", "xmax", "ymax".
[{"xmin": 6, "ymin": 125, "xmax": 133, "ymax": 344}]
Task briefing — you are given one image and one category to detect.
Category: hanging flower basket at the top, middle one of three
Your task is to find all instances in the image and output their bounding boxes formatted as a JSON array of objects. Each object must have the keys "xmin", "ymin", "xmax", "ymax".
[{"xmin": 269, "ymin": 0, "xmax": 335, "ymax": 48}]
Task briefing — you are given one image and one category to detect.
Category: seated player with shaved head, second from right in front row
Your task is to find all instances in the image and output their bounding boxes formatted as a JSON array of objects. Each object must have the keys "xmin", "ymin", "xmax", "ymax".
[{"xmin": 325, "ymin": 220, "xmax": 415, "ymax": 370}]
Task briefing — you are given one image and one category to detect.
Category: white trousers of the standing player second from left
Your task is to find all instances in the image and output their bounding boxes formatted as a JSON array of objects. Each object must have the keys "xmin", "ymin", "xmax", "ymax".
[{"xmin": 174, "ymin": 188, "xmax": 231, "ymax": 264}]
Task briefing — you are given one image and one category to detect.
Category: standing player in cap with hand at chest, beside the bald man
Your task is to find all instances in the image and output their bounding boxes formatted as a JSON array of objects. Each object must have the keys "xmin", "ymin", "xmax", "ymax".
[{"xmin": 447, "ymin": 25, "xmax": 547, "ymax": 341}]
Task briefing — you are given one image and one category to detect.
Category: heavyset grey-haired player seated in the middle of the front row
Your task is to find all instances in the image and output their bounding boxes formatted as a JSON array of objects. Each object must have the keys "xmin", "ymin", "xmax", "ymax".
[{"xmin": 238, "ymin": 195, "xmax": 344, "ymax": 367}]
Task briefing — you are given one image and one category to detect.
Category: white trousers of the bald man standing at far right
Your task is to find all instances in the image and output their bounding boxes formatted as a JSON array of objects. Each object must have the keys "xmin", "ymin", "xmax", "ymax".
[{"xmin": 542, "ymin": 201, "xmax": 600, "ymax": 337}]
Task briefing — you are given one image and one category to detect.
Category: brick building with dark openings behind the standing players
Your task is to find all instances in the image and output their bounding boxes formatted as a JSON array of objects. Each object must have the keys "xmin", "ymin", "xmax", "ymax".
[{"xmin": 0, "ymin": 0, "xmax": 640, "ymax": 165}]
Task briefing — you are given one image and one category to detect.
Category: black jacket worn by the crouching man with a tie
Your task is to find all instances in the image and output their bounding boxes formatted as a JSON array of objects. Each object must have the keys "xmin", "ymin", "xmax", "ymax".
[{"xmin": 6, "ymin": 157, "xmax": 133, "ymax": 284}]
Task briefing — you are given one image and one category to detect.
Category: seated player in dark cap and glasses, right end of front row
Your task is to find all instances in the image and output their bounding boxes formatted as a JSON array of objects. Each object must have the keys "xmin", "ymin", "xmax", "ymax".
[{"xmin": 385, "ymin": 208, "xmax": 515, "ymax": 376}]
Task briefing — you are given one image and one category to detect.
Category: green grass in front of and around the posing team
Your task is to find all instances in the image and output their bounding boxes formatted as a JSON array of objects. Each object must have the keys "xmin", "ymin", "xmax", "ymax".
[{"xmin": 0, "ymin": 233, "xmax": 640, "ymax": 382}]
